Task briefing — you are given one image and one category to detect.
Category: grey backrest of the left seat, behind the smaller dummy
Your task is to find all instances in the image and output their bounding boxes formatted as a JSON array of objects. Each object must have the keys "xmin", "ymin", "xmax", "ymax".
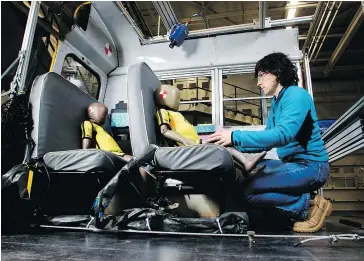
[{"xmin": 29, "ymin": 72, "xmax": 96, "ymax": 157}]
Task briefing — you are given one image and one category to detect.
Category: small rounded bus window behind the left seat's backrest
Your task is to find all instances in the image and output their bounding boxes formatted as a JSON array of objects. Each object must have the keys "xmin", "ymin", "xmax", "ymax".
[{"xmin": 61, "ymin": 55, "xmax": 100, "ymax": 100}]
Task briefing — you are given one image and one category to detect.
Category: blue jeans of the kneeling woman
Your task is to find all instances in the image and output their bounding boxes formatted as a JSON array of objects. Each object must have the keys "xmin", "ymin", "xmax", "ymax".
[{"xmin": 236, "ymin": 157, "xmax": 329, "ymax": 220}]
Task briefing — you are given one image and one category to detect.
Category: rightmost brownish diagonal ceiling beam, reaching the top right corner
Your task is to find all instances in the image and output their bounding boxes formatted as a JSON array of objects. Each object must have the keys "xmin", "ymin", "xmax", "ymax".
[{"xmin": 323, "ymin": 1, "xmax": 364, "ymax": 77}]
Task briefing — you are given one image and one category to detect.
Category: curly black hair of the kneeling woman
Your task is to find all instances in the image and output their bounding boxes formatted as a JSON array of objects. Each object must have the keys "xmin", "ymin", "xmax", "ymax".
[{"xmin": 255, "ymin": 53, "xmax": 298, "ymax": 87}]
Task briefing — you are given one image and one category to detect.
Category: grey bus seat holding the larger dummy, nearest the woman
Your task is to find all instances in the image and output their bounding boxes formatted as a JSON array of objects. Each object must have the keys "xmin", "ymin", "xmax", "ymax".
[{"xmin": 127, "ymin": 63, "xmax": 235, "ymax": 212}]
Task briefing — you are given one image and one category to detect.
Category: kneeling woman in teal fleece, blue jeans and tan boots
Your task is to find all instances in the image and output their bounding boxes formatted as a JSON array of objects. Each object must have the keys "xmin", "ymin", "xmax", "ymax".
[{"xmin": 208, "ymin": 53, "xmax": 332, "ymax": 232}]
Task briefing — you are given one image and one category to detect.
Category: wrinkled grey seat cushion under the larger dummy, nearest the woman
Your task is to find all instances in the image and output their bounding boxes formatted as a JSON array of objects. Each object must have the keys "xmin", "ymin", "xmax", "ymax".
[{"xmin": 154, "ymin": 144, "xmax": 234, "ymax": 172}]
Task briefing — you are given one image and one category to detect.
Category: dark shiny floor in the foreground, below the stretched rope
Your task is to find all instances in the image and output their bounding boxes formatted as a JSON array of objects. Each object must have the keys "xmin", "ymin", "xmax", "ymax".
[{"xmin": 1, "ymin": 216, "xmax": 364, "ymax": 261}]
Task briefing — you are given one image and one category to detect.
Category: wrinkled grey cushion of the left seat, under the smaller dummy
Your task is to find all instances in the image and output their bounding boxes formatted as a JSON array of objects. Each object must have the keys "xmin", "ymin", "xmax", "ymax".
[{"xmin": 43, "ymin": 149, "xmax": 127, "ymax": 174}]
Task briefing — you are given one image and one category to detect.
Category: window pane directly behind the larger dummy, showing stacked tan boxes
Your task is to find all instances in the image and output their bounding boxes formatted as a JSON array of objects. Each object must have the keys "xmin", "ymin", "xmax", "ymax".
[{"xmin": 162, "ymin": 77, "xmax": 212, "ymax": 126}]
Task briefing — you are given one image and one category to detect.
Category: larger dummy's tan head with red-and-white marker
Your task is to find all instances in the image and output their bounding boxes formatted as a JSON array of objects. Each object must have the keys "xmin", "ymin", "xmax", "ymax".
[{"xmin": 154, "ymin": 84, "xmax": 180, "ymax": 111}]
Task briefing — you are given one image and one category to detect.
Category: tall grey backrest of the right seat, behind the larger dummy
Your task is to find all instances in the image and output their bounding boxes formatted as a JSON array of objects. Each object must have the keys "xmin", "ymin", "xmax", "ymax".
[{"xmin": 127, "ymin": 63, "xmax": 161, "ymax": 157}]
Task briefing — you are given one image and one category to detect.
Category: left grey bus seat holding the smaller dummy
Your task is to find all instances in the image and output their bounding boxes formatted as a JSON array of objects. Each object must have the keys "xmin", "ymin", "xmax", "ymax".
[{"xmin": 29, "ymin": 72, "xmax": 126, "ymax": 214}]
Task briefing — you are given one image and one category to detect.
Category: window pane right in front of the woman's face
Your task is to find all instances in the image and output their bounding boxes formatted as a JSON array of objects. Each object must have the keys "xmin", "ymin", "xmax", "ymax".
[{"xmin": 222, "ymin": 73, "xmax": 270, "ymax": 126}]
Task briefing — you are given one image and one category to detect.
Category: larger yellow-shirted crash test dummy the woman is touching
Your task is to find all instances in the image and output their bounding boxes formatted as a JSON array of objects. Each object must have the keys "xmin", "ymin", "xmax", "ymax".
[{"xmin": 154, "ymin": 85, "xmax": 266, "ymax": 179}]
